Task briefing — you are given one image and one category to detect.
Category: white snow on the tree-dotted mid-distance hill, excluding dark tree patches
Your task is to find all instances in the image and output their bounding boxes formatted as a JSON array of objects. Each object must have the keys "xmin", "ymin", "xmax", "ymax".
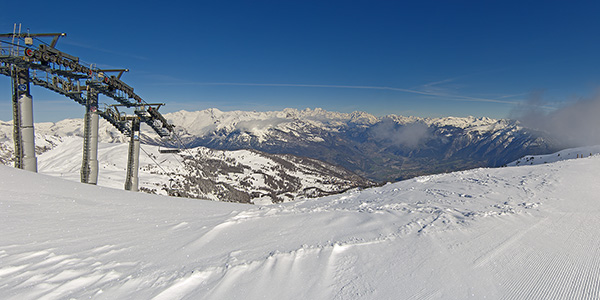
[{"xmin": 38, "ymin": 136, "xmax": 368, "ymax": 204}]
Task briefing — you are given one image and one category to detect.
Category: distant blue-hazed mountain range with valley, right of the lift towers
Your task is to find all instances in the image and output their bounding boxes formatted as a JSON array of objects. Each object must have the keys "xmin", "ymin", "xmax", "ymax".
[{"xmin": 152, "ymin": 109, "xmax": 565, "ymax": 181}]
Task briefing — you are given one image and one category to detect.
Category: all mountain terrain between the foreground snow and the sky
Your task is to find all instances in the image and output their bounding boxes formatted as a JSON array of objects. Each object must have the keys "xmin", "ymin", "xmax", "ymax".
[{"xmin": 0, "ymin": 109, "xmax": 561, "ymax": 203}]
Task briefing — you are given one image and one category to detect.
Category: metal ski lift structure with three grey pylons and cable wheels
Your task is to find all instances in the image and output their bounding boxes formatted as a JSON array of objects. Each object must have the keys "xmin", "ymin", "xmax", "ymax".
[{"xmin": 0, "ymin": 24, "xmax": 174, "ymax": 191}]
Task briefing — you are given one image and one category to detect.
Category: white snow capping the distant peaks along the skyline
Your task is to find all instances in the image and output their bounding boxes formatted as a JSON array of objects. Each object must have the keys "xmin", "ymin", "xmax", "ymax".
[{"xmin": 0, "ymin": 108, "xmax": 510, "ymax": 149}]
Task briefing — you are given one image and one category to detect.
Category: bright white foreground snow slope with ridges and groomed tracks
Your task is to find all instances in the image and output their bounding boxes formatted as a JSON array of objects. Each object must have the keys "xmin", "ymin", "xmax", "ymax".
[{"xmin": 0, "ymin": 156, "xmax": 600, "ymax": 299}]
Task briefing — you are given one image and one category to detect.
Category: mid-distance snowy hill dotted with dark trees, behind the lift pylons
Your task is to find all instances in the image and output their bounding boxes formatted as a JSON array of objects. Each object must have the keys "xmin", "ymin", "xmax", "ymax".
[{"xmin": 38, "ymin": 136, "xmax": 374, "ymax": 203}]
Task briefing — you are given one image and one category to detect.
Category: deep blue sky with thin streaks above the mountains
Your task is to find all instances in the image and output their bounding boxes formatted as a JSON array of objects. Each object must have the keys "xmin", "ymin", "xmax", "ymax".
[{"xmin": 0, "ymin": 1, "xmax": 600, "ymax": 122}]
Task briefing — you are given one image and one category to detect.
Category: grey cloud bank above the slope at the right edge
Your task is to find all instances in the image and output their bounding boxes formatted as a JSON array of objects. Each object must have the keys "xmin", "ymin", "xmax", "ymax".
[{"xmin": 512, "ymin": 93, "xmax": 600, "ymax": 146}]
